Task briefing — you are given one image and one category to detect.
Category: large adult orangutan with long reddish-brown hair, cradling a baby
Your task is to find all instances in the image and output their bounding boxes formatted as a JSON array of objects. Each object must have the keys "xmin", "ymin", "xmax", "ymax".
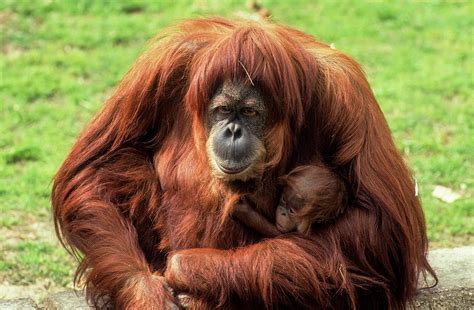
[{"xmin": 52, "ymin": 18, "xmax": 433, "ymax": 309}]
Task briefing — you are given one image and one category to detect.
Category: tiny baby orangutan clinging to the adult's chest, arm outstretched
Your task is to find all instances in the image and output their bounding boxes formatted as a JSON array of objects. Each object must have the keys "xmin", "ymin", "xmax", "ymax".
[{"xmin": 231, "ymin": 165, "xmax": 347, "ymax": 237}]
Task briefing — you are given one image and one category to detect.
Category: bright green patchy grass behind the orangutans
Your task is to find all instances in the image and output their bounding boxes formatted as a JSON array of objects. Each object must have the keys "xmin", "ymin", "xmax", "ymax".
[{"xmin": 0, "ymin": 0, "xmax": 474, "ymax": 298}]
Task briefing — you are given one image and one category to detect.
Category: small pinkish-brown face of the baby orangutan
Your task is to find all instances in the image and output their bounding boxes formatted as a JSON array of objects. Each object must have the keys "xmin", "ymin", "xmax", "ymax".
[{"xmin": 275, "ymin": 187, "xmax": 304, "ymax": 233}]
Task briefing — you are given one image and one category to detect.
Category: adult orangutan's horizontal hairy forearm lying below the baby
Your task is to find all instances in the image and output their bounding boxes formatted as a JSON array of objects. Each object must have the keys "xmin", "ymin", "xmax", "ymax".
[{"xmin": 164, "ymin": 209, "xmax": 402, "ymax": 309}]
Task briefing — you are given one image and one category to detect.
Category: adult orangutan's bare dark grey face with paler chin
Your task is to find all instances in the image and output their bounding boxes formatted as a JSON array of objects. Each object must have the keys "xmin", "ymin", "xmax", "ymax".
[{"xmin": 206, "ymin": 82, "xmax": 267, "ymax": 179}]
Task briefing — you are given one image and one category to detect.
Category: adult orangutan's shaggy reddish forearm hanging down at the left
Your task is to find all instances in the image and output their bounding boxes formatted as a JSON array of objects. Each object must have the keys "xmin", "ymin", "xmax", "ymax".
[{"xmin": 53, "ymin": 152, "xmax": 181, "ymax": 309}]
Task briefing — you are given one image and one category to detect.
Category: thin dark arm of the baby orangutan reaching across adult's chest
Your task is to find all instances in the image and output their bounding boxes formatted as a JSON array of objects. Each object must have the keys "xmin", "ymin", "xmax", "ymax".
[{"xmin": 231, "ymin": 198, "xmax": 281, "ymax": 238}]
